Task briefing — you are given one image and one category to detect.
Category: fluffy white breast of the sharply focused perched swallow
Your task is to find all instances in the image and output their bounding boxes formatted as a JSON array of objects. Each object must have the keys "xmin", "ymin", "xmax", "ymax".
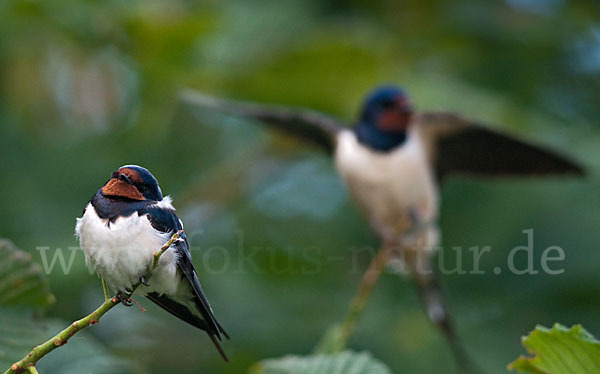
[{"xmin": 75, "ymin": 203, "xmax": 180, "ymax": 295}]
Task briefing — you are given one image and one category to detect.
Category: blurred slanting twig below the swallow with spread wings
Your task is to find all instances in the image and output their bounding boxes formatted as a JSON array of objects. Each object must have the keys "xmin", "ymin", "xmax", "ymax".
[{"xmin": 340, "ymin": 245, "xmax": 389, "ymax": 344}]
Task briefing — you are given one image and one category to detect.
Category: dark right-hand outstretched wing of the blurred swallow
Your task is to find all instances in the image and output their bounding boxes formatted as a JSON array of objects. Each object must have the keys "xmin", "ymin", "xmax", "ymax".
[{"xmin": 416, "ymin": 112, "xmax": 585, "ymax": 180}]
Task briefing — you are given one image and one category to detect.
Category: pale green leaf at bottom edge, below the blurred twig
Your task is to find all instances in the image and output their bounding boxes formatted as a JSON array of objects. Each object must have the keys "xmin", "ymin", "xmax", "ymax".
[{"xmin": 250, "ymin": 351, "xmax": 391, "ymax": 374}]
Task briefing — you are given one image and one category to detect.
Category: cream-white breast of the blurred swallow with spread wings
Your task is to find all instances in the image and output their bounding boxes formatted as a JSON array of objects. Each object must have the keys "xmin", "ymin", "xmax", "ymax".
[{"xmin": 335, "ymin": 130, "xmax": 438, "ymax": 243}]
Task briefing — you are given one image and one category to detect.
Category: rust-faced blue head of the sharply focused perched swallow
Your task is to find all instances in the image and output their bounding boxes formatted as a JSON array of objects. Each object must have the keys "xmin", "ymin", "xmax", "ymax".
[{"xmin": 101, "ymin": 165, "xmax": 163, "ymax": 201}]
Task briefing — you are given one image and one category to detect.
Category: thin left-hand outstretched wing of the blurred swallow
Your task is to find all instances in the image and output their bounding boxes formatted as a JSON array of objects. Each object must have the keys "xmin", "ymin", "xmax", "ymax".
[{"xmin": 181, "ymin": 90, "xmax": 346, "ymax": 154}]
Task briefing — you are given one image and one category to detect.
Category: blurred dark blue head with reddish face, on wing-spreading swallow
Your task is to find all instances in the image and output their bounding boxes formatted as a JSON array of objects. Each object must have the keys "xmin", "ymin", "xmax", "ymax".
[{"xmin": 356, "ymin": 86, "xmax": 414, "ymax": 151}]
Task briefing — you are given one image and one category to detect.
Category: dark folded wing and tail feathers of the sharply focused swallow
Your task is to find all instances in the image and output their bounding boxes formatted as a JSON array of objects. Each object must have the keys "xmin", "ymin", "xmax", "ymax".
[{"xmin": 139, "ymin": 207, "xmax": 229, "ymax": 361}]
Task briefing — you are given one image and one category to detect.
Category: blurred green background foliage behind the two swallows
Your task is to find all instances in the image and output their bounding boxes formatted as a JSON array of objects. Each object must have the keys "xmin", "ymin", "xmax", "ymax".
[{"xmin": 0, "ymin": 0, "xmax": 600, "ymax": 373}]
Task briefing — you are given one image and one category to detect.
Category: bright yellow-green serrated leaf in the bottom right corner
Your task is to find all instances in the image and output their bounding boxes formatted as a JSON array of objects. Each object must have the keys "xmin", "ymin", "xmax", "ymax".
[{"xmin": 508, "ymin": 323, "xmax": 600, "ymax": 374}]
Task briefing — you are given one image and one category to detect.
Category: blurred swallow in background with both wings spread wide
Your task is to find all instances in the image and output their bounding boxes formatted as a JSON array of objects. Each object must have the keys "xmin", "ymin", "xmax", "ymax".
[{"xmin": 183, "ymin": 86, "xmax": 584, "ymax": 372}]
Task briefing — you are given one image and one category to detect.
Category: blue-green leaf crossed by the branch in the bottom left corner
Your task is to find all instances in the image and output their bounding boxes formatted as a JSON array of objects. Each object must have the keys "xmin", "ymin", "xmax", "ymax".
[{"xmin": 0, "ymin": 308, "xmax": 131, "ymax": 374}]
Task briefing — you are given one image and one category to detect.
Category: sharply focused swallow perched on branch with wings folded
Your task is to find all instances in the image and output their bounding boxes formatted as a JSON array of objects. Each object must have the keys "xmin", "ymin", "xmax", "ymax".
[{"xmin": 75, "ymin": 165, "xmax": 229, "ymax": 361}]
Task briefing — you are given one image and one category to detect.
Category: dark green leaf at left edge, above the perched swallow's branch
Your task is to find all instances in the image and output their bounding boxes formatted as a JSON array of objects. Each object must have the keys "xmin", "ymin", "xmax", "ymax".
[{"xmin": 0, "ymin": 239, "xmax": 54, "ymax": 307}]
